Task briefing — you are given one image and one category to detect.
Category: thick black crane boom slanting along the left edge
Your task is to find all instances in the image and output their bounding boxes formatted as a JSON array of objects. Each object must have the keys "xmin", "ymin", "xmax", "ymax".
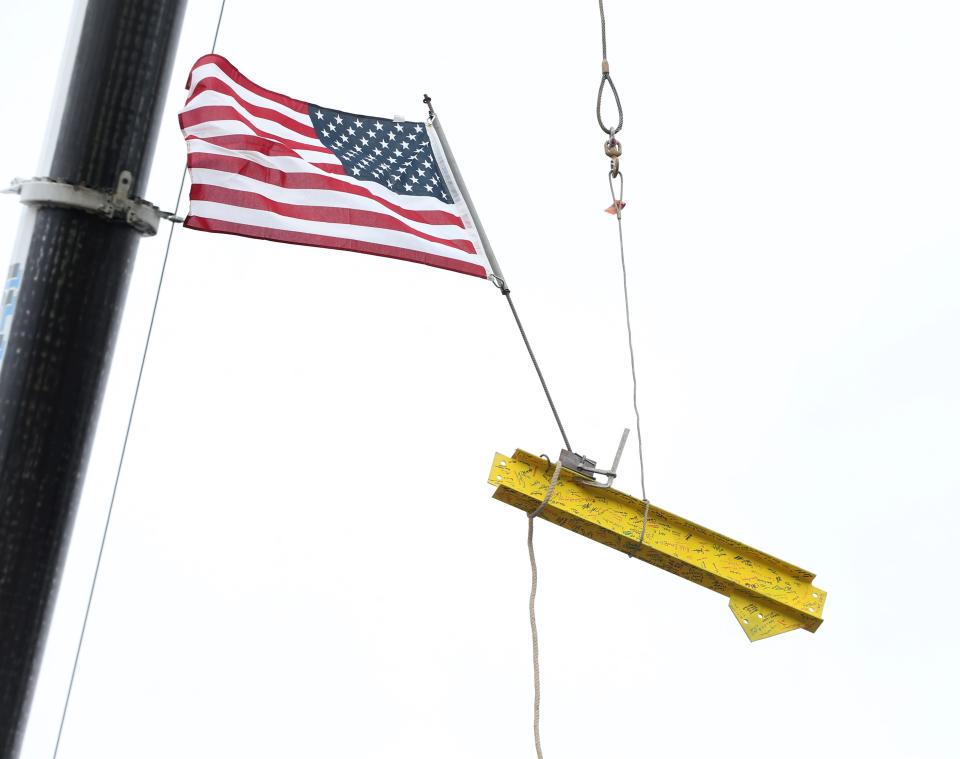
[{"xmin": 0, "ymin": 0, "xmax": 185, "ymax": 757}]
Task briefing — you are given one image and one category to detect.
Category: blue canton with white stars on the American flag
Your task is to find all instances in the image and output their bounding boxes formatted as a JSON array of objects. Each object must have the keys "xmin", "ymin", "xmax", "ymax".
[{"xmin": 310, "ymin": 105, "xmax": 453, "ymax": 204}]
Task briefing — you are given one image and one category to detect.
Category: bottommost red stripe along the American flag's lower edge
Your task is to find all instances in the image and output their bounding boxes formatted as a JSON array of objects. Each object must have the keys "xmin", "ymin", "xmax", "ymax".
[{"xmin": 183, "ymin": 216, "xmax": 487, "ymax": 279}]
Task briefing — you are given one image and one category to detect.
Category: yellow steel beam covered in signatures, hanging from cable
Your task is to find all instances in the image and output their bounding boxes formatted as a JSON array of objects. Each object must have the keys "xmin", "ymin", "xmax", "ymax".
[{"xmin": 489, "ymin": 450, "xmax": 827, "ymax": 641}]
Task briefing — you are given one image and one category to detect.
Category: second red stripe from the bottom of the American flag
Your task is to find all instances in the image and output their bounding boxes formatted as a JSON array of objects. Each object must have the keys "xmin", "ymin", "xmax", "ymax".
[{"xmin": 190, "ymin": 184, "xmax": 477, "ymax": 255}]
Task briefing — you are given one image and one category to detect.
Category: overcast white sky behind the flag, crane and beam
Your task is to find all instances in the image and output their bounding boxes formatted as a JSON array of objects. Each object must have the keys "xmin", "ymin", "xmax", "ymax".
[{"xmin": 0, "ymin": 0, "xmax": 960, "ymax": 759}]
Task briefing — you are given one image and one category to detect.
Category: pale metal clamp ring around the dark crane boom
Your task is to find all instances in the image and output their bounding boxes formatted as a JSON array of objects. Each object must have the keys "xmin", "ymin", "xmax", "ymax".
[{"xmin": 4, "ymin": 171, "xmax": 183, "ymax": 236}]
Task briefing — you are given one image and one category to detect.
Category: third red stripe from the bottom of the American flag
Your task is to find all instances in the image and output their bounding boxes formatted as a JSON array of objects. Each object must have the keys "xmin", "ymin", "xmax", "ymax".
[{"xmin": 187, "ymin": 153, "xmax": 463, "ymax": 229}]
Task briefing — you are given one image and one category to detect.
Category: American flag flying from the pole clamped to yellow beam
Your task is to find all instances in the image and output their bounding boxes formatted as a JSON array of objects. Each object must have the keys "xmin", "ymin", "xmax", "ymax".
[{"xmin": 180, "ymin": 55, "xmax": 491, "ymax": 277}]
